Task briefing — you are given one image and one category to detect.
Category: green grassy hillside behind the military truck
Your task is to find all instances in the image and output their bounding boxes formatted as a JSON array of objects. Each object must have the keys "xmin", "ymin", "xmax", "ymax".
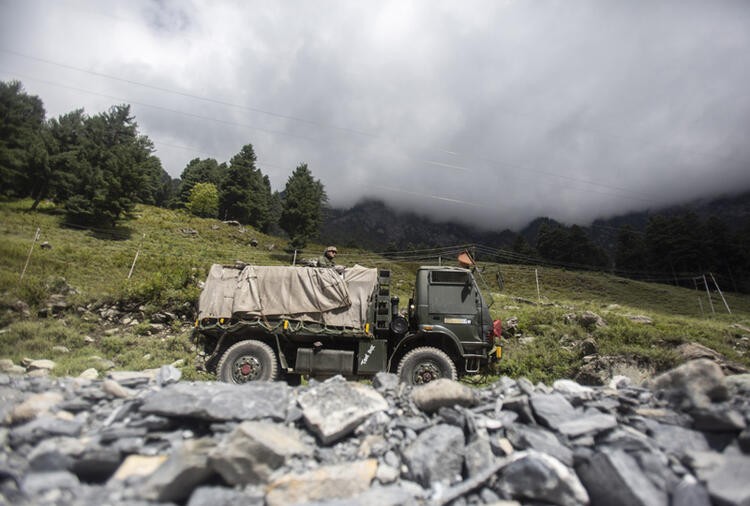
[{"xmin": 0, "ymin": 201, "xmax": 750, "ymax": 381}]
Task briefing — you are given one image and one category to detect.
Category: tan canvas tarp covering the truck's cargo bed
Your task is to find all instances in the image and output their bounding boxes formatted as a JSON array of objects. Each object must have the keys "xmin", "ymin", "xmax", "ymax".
[{"xmin": 198, "ymin": 265, "xmax": 377, "ymax": 329}]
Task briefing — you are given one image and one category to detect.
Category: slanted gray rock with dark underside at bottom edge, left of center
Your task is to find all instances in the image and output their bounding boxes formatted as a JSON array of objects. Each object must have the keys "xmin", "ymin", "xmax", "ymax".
[{"xmin": 138, "ymin": 439, "xmax": 215, "ymax": 502}]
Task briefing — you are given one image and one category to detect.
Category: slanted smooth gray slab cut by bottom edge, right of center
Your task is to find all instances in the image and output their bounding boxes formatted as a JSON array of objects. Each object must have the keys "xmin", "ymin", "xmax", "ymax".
[{"xmin": 576, "ymin": 450, "xmax": 668, "ymax": 506}]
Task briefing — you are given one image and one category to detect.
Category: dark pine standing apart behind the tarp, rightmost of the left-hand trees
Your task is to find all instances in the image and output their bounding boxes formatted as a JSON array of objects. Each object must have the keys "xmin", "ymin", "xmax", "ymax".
[{"xmin": 279, "ymin": 163, "xmax": 328, "ymax": 249}]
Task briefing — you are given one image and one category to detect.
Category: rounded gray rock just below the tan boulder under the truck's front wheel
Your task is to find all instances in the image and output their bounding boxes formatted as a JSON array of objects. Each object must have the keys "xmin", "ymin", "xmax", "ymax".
[{"xmin": 403, "ymin": 424, "xmax": 464, "ymax": 487}]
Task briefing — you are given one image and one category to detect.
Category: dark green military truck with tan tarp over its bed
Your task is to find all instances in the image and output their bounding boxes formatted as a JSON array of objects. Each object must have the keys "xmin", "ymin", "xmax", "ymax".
[{"xmin": 194, "ymin": 265, "xmax": 502, "ymax": 385}]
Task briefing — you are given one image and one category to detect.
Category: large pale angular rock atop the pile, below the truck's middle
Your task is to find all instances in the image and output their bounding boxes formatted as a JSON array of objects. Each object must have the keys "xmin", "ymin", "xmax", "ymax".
[{"xmin": 298, "ymin": 377, "xmax": 388, "ymax": 444}]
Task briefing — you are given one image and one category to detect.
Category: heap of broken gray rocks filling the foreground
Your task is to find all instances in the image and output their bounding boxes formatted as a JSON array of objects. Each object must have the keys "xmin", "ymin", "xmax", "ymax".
[{"xmin": 0, "ymin": 360, "xmax": 750, "ymax": 506}]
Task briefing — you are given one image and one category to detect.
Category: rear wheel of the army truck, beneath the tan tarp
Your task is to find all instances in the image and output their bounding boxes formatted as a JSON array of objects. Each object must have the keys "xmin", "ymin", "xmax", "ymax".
[{"xmin": 216, "ymin": 341, "xmax": 279, "ymax": 383}]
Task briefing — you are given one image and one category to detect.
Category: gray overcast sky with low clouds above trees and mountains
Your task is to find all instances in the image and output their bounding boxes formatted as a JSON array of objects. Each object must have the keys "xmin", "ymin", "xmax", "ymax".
[{"xmin": 0, "ymin": 0, "xmax": 750, "ymax": 229}]
